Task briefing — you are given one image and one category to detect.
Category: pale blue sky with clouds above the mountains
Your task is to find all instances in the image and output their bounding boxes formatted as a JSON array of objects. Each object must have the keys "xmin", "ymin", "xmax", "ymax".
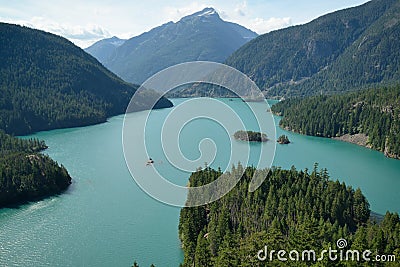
[{"xmin": 0, "ymin": 0, "xmax": 367, "ymax": 47}]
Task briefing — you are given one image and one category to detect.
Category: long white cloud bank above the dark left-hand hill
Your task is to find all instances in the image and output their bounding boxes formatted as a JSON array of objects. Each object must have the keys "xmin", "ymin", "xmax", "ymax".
[{"xmin": 2, "ymin": 17, "xmax": 111, "ymax": 48}]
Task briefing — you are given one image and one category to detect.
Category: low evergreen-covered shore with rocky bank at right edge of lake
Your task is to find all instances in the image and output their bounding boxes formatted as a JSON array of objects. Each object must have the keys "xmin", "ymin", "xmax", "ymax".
[{"xmin": 271, "ymin": 85, "xmax": 400, "ymax": 159}]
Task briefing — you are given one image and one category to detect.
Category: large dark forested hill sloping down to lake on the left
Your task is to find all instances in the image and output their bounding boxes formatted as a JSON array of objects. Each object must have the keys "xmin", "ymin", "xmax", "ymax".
[{"xmin": 0, "ymin": 23, "xmax": 172, "ymax": 135}]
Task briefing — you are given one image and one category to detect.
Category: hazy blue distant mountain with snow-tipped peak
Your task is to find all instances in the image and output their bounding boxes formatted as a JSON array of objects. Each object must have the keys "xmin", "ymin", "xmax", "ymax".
[{"xmin": 85, "ymin": 8, "xmax": 257, "ymax": 84}]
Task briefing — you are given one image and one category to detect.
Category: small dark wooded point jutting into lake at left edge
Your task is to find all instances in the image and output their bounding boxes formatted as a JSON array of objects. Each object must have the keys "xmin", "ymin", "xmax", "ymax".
[{"xmin": 0, "ymin": 131, "xmax": 71, "ymax": 208}]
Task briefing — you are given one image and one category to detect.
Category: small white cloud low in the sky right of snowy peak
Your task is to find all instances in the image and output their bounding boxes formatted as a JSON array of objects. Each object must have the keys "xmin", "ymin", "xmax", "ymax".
[{"xmin": 244, "ymin": 17, "xmax": 292, "ymax": 34}]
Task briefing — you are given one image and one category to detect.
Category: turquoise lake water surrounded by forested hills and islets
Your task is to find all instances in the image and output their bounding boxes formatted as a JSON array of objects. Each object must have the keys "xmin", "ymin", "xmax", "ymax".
[{"xmin": 0, "ymin": 99, "xmax": 400, "ymax": 266}]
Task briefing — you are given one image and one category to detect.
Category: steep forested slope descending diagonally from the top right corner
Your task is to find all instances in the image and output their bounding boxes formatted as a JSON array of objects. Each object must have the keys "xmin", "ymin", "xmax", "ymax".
[{"xmin": 289, "ymin": 1, "xmax": 400, "ymax": 95}]
